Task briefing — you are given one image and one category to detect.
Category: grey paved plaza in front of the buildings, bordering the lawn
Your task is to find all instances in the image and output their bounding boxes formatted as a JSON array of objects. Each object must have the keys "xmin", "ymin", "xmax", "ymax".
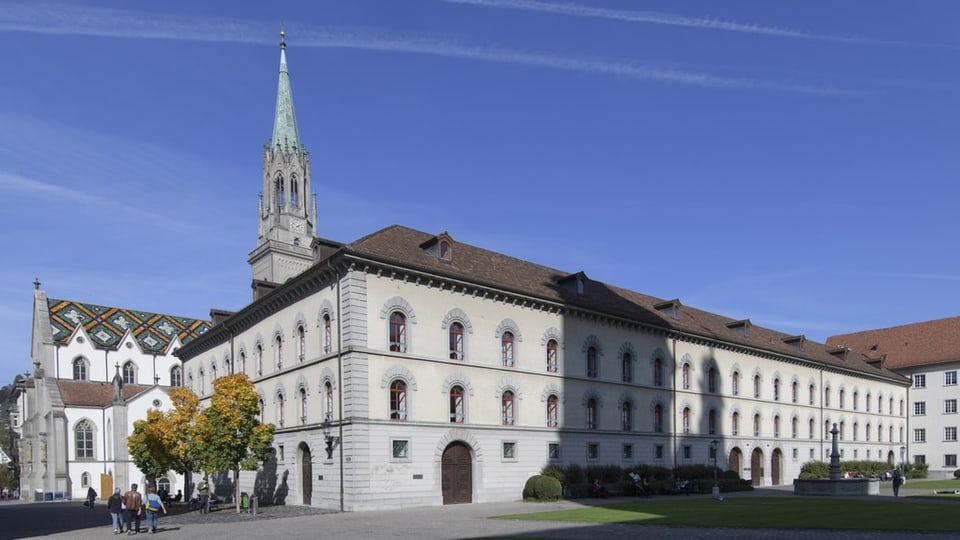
[{"xmin": 0, "ymin": 488, "xmax": 957, "ymax": 540}]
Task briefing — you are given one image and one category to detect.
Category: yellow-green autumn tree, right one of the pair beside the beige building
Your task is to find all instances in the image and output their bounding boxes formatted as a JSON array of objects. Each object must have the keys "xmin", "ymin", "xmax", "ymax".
[{"xmin": 195, "ymin": 373, "xmax": 273, "ymax": 512}]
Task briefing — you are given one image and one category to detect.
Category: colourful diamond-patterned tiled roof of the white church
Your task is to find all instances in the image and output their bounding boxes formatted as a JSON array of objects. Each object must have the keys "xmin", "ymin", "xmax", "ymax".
[{"xmin": 47, "ymin": 298, "xmax": 210, "ymax": 353}]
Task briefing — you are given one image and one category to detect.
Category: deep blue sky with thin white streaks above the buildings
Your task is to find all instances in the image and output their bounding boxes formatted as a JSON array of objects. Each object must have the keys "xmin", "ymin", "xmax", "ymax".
[{"xmin": 0, "ymin": 0, "xmax": 960, "ymax": 384}]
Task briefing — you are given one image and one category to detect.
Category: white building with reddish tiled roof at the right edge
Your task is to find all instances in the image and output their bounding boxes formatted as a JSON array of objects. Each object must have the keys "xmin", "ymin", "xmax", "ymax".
[{"xmin": 827, "ymin": 317, "xmax": 960, "ymax": 478}]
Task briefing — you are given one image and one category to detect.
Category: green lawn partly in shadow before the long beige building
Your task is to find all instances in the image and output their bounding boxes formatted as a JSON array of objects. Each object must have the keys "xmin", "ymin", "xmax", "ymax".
[{"xmin": 499, "ymin": 498, "xmax": 960, "ymax": 532}]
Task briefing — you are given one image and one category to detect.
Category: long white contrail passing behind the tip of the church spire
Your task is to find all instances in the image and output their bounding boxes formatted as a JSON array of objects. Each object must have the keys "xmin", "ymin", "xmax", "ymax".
[{"xmin": 0, "ymin": 4, "xmax": 860, "ymax": 95}]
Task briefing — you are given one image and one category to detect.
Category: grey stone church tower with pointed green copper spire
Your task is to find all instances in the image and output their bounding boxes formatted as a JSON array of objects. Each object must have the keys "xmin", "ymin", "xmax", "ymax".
[{"xmin": 248, "ymin": 31, "xmax": 317, "ymax": 300}]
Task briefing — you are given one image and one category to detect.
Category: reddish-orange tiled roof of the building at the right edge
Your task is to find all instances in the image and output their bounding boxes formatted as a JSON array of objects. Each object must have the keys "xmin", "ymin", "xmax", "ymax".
[{"xmin": 827, "ymin": 317, "xmax": 960, "ymax": 369}]
